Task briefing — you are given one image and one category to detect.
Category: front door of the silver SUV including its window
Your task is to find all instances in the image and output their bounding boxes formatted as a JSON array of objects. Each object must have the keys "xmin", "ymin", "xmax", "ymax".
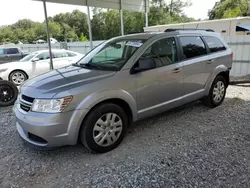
[{"xmin": 133, "ymin": 37, "xmax": 183, "ymax": 118}]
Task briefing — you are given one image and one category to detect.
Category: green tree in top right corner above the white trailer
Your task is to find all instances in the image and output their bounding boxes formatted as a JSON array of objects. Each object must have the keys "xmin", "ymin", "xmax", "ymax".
[{"xmin": 208, "ymin": 0, "xmax": 250, "ymax": 19}]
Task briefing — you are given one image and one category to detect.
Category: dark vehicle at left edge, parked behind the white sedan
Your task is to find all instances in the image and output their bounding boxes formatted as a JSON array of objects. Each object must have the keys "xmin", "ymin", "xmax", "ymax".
[{"xmin": 0, "ymin": 47, "xmax": 28, "ymax": 64}]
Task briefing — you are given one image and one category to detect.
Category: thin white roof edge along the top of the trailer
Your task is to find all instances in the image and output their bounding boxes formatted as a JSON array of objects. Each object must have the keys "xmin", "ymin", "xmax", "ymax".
[{"xmin": 144, "ymin": 17, "xmax": 250, "ymax": 29}]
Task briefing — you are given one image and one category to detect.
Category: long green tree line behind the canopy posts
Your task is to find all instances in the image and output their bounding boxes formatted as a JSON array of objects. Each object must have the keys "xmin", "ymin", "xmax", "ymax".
[{"xmin": 0, "ymin": 0, "xmax": 194, "ymax": 43}]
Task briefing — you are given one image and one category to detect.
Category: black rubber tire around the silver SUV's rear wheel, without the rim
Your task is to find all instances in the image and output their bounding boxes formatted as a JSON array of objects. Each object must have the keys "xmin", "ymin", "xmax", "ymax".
[{"xmin": 203, "ymin": 76, "xmax": 227, "ymax": 108}]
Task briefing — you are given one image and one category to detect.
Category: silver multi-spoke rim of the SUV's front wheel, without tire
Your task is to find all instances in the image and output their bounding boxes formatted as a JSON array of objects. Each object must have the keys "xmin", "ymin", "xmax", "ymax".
[{"xmin": 93, "ymin": 113, "xmax": 123, "ymax": 147}]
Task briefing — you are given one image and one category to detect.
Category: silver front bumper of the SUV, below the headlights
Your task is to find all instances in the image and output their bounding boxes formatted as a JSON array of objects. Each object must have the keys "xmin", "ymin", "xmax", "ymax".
[{"xmin": 13, "ymin": 104, "xmax": 88, "ymax": 148}]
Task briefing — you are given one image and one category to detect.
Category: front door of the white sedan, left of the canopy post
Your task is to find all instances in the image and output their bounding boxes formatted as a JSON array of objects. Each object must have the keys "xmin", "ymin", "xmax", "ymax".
[{"xmin": 31, "ymin": 52, "xmax": 50, "ymax": 77}]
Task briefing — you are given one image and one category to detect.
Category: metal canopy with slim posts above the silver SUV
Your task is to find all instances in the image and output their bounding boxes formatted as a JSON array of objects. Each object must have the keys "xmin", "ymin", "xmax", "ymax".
[{"xmin": 33, "ymin": 0, "xmax": 149, "ymax": 69}]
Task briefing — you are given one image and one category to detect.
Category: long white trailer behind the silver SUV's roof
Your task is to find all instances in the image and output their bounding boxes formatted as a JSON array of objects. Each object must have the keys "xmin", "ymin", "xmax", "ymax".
[{"xmin": 144, "ymin": 17, "xmax": 250, "ymax": 36}]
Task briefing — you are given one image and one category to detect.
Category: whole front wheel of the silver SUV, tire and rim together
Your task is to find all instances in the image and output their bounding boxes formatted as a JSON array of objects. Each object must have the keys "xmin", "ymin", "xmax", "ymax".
[{"xmin": 80, "ymin": 103, "xmax": 128, "ymax": 153}]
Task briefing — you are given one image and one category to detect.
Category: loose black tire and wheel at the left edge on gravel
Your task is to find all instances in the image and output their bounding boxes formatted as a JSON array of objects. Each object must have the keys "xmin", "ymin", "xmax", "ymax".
[{"xmin": 0, "ymin": 80, "xmax": 18, "ymax": 107}]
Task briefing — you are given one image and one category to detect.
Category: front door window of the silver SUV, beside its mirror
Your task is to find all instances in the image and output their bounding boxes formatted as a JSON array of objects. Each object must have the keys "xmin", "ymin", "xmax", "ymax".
[{"xmin": 142, "ymin": 38, "xmax": 177, "ymax": 67}]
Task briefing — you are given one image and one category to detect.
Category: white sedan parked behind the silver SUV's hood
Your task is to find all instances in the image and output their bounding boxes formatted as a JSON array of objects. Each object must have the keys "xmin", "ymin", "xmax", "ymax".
[{"xmin": 0, "ymin": 50, "xmax": 84, "ymax": 86}]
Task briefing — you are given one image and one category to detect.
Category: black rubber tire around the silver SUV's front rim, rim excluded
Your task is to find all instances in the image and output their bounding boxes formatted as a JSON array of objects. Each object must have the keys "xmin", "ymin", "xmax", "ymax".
[{"xmin": 80, "ymin": 103, "xmax": 128, "ymax": 153}]
